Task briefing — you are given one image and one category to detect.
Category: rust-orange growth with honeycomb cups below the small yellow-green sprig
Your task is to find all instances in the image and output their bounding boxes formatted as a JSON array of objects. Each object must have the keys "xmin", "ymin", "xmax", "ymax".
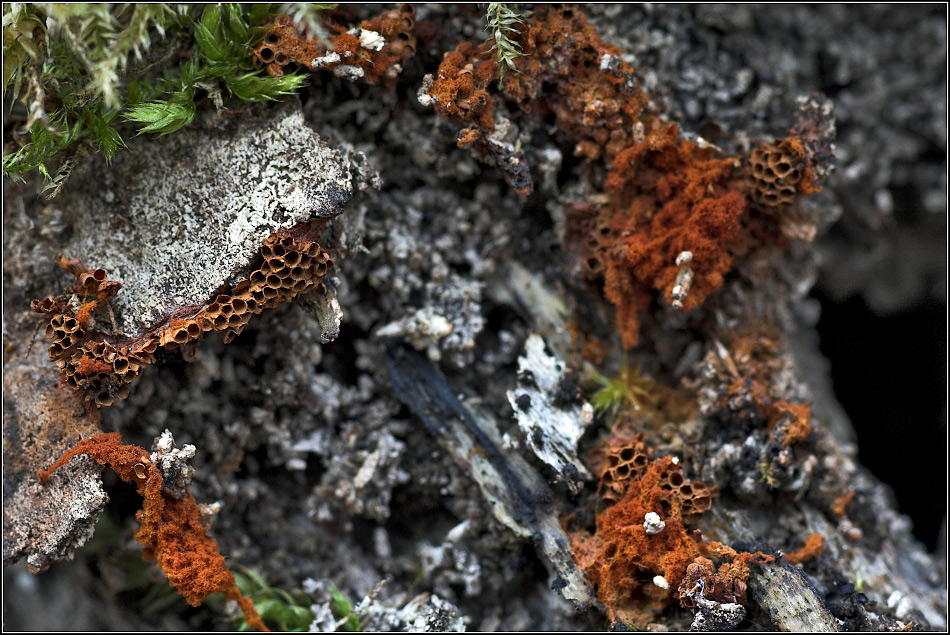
[{"xmin": 571, "ymin": 435, "xmax": 775, "ymax": 628}]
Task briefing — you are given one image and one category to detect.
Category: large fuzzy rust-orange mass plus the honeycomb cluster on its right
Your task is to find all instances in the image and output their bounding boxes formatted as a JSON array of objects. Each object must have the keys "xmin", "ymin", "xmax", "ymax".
[{"xmin": 568, "ymin": 120, "xmax": 820, "ymax": 348}]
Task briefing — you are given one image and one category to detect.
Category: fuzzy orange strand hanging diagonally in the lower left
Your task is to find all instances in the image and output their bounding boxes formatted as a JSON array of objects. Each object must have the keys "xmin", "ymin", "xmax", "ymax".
[{"xmin": 39, "ymin": 432, "xmax": 268, "ymax": 631}]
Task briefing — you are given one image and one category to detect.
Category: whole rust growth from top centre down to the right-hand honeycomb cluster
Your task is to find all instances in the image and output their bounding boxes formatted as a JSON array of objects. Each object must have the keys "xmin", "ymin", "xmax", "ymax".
[{"xmin": 423, "ymin": 5, "xmax": 834, "ymax": 348}]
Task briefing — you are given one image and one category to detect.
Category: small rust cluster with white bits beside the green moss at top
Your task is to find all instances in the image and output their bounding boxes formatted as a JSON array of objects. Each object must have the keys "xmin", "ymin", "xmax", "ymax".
[{"xmin": 252, "ymin": 4, "xmax": 416, "ymax": 84}]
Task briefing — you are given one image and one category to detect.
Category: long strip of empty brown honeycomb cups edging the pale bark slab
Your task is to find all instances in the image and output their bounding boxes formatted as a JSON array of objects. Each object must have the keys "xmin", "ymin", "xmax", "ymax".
[{"xmin": 30, "ymin": 223, "xmax": 333, "ymax": 407}]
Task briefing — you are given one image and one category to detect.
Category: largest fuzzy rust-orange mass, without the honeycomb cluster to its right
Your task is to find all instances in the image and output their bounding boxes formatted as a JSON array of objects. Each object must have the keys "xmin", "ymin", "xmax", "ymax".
[{"xmin": 600, "ymin": 124, "xmax": 746, "ymax": 348}]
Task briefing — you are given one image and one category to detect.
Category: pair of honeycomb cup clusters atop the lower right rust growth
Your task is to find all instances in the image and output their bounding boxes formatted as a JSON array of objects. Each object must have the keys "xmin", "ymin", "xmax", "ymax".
[{"xmin": 594, "ymin": 435, "xmax": 712, "ymax": 524}]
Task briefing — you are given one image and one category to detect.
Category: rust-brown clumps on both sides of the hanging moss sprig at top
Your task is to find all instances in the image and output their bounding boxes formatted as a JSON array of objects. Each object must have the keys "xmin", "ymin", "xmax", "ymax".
[{"xmin": 428, "ymin": 5, "xmax": 649, "ymax": 160}]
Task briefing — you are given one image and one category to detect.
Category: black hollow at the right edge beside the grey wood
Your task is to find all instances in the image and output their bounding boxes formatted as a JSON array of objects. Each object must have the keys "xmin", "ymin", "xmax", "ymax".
[{"xmin": 815, "ymin": 294, "xmax": 947, "ymax": 549}]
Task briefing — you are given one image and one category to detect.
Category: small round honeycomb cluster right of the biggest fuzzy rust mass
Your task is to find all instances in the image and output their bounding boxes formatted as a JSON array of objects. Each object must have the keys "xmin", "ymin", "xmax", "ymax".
[{"xmin": 746, "ymin": 137, "xmax": 821, "ymax": 209}]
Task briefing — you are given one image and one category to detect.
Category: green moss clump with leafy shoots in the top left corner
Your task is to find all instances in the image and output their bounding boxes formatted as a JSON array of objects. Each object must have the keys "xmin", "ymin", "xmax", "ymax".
[{"xmin": 3, "ymin": 3, "xmax": 318, "ymax": 185}]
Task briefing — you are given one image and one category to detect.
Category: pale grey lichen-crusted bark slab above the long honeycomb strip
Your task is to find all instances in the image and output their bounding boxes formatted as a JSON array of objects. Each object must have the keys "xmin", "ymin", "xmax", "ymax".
[{"xmin": 54, "ymin": 104, "xmax": 358, "ymax": 336}]
